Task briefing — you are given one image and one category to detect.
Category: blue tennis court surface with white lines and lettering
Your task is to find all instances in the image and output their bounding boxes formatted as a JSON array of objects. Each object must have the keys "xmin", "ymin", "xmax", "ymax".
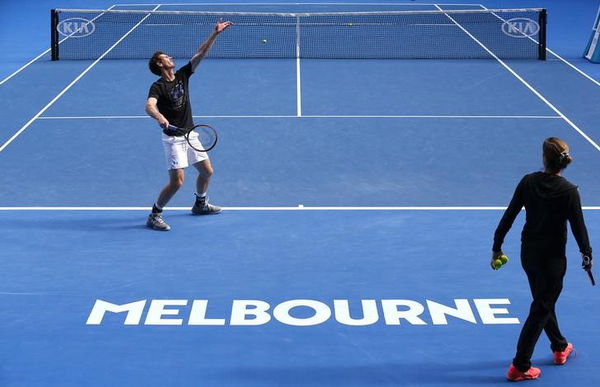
[{"xmin": 0, "ymin": 0, "xmax": 600, "ymax": 386}]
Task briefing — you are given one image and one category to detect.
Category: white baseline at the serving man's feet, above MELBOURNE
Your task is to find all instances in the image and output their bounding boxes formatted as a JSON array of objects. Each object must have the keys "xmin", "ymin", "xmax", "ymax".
[{"xmin": 0, "ymin": 206, "xmax": 600, "ymax": 211}]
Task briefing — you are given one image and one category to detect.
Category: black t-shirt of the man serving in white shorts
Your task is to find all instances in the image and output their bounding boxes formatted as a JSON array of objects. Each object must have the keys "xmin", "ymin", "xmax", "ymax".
[{"xmin": 148, "ymin": 62, "xmax": 194, "ymax": 128}]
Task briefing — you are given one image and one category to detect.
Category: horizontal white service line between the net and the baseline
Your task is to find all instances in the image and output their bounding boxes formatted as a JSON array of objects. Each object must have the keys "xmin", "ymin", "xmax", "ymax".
[{"xmin": 38, "ymin": 114, "xmax": 562, "ymax": 120}]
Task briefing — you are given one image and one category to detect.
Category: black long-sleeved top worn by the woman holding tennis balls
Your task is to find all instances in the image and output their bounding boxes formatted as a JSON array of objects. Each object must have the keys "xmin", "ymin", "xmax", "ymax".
[{"xmin": 492, "ymin": 172, "xmax": 592, "ymax": 256}]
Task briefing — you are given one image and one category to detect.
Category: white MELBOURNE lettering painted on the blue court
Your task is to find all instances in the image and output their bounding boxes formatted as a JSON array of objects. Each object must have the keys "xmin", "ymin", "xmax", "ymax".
[{"xmin": 86, "ymin": 298, "xmax": 519, "ymax": 327}]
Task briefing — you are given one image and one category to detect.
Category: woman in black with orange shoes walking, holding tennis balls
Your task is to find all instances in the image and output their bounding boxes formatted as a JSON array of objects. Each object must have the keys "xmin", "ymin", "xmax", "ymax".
[{"xmin": 492, "ymin": 137, "xmax": 592, "ymax": 381}]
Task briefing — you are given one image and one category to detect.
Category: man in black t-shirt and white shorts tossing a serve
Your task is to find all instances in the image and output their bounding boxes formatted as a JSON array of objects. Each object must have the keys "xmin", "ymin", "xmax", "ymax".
[{"xmin": 146, "ymin": 21, "xmax": 232, "ymax": 231}]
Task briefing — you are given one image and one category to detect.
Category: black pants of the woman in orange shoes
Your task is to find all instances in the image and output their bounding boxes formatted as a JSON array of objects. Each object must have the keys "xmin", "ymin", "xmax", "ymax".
[{"xmin": 513, "ymin": 241, "xmax": 568, "ymax": 372}]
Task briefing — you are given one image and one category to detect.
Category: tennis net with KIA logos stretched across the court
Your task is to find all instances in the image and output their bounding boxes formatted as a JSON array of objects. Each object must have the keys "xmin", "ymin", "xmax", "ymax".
[{"xmin": 51, "ymin": 9, "xmax": 546, "ymax": 60}]
